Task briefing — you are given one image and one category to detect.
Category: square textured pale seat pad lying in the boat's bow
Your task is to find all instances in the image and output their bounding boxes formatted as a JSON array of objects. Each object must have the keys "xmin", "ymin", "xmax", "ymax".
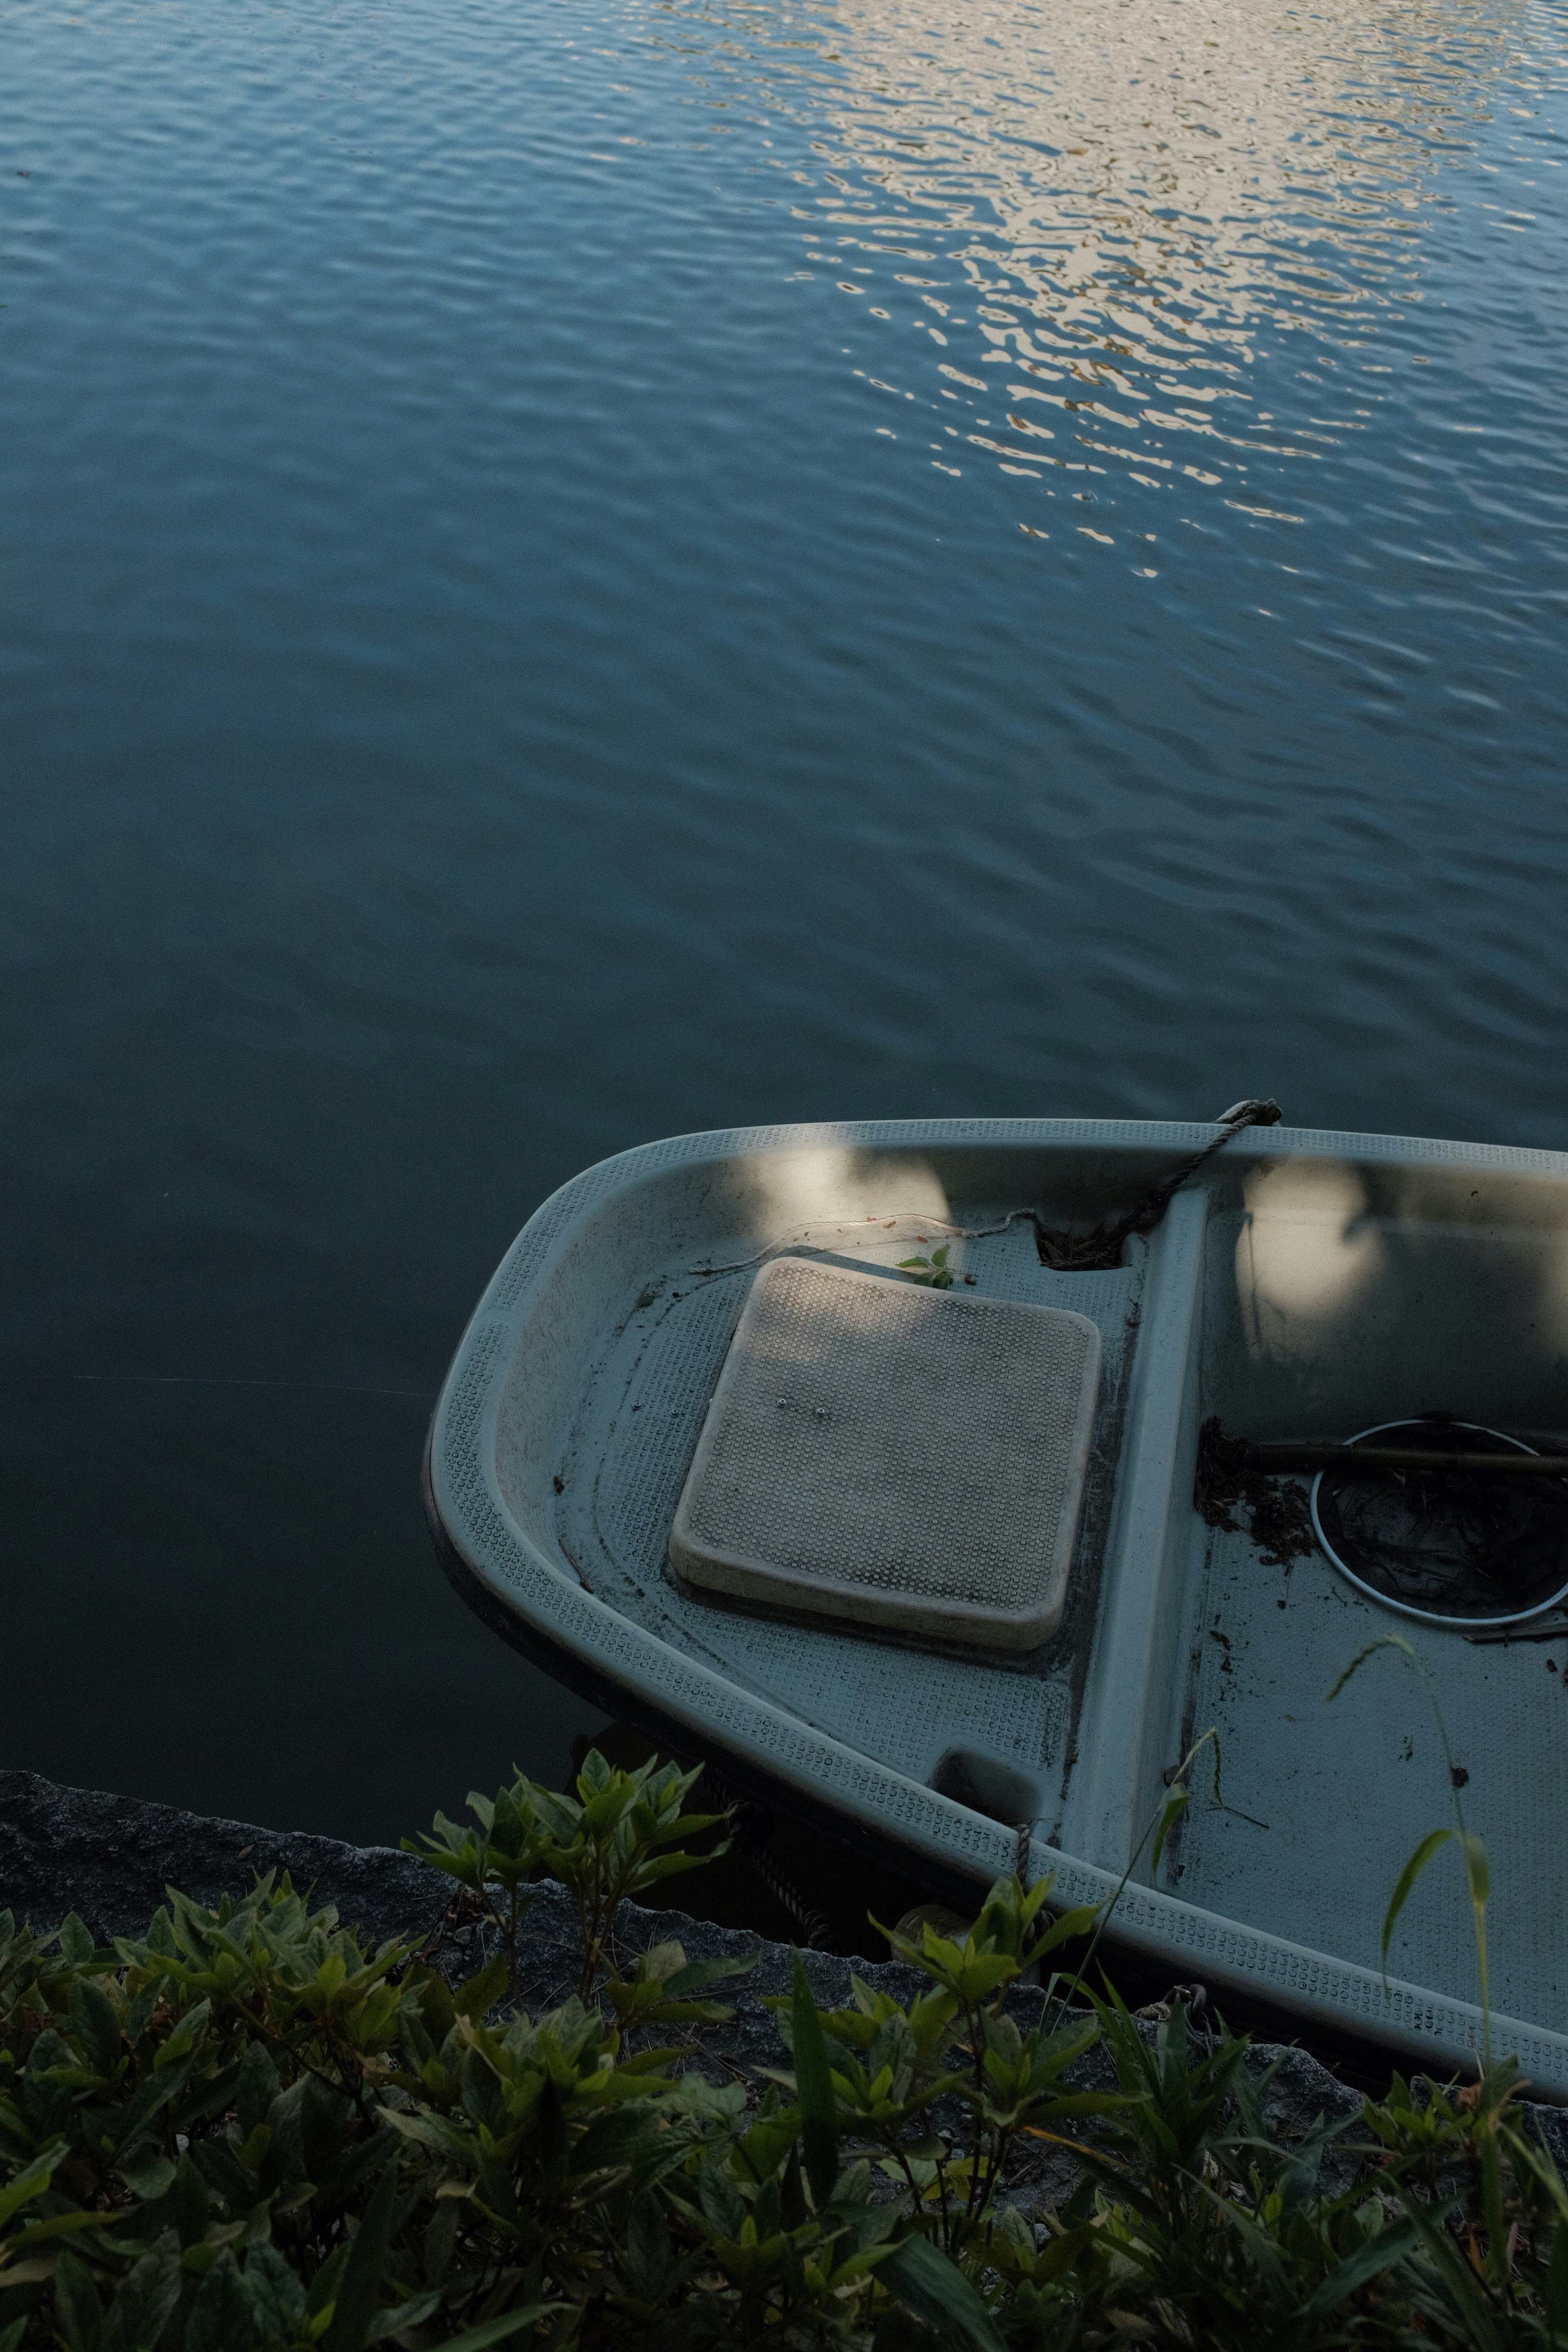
[{"xmin": 670, "ymin": 1258, "xmax": 1100, "ymax": 1649}]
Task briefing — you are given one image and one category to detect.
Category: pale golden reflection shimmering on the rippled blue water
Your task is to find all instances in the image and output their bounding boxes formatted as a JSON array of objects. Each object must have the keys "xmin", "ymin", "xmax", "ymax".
[{"xmin": 752, "ymin": 0, "xmax": 1516, "ymax": 510}]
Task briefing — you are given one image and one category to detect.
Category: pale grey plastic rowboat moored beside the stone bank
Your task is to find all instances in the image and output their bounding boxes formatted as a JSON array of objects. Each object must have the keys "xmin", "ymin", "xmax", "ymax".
[{"xmin": 426, "ymin": 1119, "xmax": 1568, "ymax": 2096}]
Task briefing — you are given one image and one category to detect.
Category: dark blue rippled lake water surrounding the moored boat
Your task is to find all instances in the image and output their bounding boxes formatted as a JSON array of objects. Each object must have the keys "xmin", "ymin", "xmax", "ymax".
[{"xmin": 0, "ymin": 0, "xmax": 1568, "ymax": 1837}]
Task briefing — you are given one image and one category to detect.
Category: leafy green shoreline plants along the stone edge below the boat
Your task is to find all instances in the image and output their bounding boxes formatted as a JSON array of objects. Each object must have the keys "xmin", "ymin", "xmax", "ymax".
[{"xmin": 0, "ymin": 1740, "xmax": 1568, "ymax": 2352}]
